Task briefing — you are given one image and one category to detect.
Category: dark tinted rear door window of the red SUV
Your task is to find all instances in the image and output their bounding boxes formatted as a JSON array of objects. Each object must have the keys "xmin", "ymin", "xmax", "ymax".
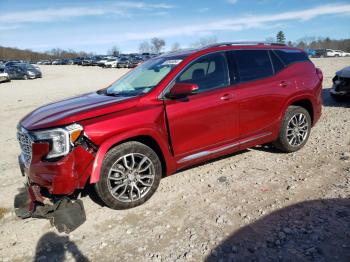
[{"xmin": 233, "ymin": 50, "xmax": 273, "ymax": 82}]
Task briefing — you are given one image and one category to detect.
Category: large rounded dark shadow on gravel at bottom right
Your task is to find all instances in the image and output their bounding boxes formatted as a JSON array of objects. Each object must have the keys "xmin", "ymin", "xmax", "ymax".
[{"xmin": 205, "ymin": 198, "xmax": 350, "ymax": 262}]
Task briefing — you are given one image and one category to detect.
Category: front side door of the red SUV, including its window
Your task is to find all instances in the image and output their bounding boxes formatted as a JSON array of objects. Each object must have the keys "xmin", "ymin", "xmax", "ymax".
[{"xmin": 165, "ymin": 52, "xmax": 238, "ymax": 162}]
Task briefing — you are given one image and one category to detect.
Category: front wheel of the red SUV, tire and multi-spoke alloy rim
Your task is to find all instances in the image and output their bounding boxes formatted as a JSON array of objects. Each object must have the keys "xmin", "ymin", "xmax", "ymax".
[{"xmin": 95, "ymin": 141, "xmax": 162, "ymax": 209}]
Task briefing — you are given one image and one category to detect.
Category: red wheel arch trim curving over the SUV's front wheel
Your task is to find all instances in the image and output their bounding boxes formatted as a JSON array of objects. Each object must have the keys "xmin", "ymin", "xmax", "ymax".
[{"xmin": 90, "ymin": 128, "xmax": 176, "ymax": 184}]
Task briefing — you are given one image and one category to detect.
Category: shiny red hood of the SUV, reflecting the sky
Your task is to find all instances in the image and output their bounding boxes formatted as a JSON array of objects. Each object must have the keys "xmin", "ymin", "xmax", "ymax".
[{"xmin": 20, "ymin": 93, "xmax": 138, "ymax": 130}]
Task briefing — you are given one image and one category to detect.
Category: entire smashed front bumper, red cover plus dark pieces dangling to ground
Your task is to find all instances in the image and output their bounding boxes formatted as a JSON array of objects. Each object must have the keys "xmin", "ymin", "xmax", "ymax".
[{"xmin": 14, "ymin": 143, "xmax": 94, "ymax": 233}]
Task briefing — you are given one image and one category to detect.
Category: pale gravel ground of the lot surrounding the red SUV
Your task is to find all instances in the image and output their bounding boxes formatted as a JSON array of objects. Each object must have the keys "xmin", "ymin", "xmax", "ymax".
[{"xmin": 0, "ymin": 58, "xmax": 350, "ymax": 261}]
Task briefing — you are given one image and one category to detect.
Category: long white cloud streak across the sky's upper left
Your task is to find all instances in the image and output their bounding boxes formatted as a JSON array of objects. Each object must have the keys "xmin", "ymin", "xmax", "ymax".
[{"xmin": 0, "ymin": 2, "xmax": 174, "ymax": 24}]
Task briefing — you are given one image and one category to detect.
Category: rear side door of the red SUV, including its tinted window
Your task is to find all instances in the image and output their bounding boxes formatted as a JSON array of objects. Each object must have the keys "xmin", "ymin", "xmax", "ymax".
[{"xmin": 227, "ymin": 50, "xmax": 293, "ymax": 143}]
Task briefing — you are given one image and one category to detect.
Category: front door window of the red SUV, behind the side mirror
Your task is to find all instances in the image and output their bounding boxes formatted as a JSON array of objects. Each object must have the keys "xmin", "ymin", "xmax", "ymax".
[{"xmin": 176, "ymin": 53, "xmax": 229, "ymax": 92}]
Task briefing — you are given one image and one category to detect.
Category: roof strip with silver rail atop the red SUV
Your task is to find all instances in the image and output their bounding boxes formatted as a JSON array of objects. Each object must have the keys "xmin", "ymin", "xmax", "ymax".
[{"xmin": 159, "ymin": 42, "xmax": 300, "ymax": 58}]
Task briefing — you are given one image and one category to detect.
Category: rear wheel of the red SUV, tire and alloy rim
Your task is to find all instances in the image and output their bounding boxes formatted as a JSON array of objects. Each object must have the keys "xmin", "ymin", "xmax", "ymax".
[{"xmin": 273, "ymin": 106, "xmax": 311, "ymax": 153}]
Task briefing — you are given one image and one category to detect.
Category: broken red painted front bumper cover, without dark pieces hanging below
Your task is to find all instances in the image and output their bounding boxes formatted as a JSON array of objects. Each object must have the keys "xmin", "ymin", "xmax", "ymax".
[{"xmin": 19, "ymin": 143, "xmax": 94, "ymax": 195}]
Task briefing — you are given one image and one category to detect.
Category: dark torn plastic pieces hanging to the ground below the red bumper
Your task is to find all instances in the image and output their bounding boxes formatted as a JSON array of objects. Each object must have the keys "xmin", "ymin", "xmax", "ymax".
[{"xmin": 14, "ymin": 185, "xmax": 86, "ymax": 233}]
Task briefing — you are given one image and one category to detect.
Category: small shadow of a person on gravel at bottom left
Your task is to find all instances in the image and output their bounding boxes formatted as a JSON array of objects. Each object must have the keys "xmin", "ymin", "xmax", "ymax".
[{"xmin": 33, "ymin": 232, "xmax": 89, "ymax": 262}]
